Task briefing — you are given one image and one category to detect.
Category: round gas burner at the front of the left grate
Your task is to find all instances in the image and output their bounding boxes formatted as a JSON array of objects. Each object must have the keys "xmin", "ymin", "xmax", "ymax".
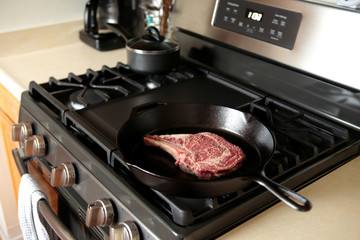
[{"xmin": 68, "ymin": 88, "xmax": 110, "ymax": 110}]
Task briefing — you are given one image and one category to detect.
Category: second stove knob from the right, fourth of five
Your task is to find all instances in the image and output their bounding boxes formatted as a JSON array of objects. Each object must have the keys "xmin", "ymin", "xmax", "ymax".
[{"xmin": 85, "ymin": 198, "xmax": 115, "ymax": 227}]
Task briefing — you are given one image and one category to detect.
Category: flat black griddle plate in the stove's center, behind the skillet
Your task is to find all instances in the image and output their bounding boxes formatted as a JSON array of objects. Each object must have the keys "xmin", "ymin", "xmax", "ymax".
[{"xmin": 77, "ymin": 74, "xmax": 261, "ymax": 142}]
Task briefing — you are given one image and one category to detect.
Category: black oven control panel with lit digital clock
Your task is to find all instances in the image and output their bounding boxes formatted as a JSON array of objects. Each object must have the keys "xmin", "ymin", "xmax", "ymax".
[{"xmin": 212, "ymin": 0, "xmax": 302, "ymax": 50}]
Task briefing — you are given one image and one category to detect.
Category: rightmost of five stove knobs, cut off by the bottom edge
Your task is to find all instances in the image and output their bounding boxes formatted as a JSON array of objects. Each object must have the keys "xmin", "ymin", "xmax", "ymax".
[{"xmin": 110, "ymin": 221, "xmax": 140, "ymax": 240}]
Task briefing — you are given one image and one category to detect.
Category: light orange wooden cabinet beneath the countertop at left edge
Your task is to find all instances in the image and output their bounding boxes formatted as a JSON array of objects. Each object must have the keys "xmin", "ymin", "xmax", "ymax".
[{"xmin": 0, "ymin": 84, "xmax": 21, "ymax": 199}]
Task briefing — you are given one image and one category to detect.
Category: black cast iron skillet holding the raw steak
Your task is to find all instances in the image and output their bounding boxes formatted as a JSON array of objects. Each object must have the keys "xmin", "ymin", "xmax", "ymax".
[{"xmin": 117, "ymin": 103, "xmax": 311, "ymax": 211}]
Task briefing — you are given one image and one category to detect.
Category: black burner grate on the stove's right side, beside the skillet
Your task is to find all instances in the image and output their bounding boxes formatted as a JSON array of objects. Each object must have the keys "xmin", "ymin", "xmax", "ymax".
[{"xmin": 250, "ymin": 98, "xmax": 349, "ymax": 177}]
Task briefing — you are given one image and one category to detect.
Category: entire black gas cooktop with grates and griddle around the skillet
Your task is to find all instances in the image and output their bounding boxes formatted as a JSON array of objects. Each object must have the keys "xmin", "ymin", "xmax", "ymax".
[{"xmin": 26, "ymin": 59, "xmax": 359, "ymax": 236}]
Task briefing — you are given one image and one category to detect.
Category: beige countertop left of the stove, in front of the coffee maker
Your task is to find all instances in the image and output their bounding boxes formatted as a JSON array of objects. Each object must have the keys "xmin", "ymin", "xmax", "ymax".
[{"xmin": 0, "ymin": 21, "xmax": 126, "ymax": 100}]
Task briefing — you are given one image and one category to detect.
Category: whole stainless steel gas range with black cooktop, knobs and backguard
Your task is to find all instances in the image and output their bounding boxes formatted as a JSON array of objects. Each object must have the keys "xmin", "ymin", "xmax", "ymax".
[{"xmin": 14, "ymin": 0, "xmax": 360, "ymax": 239}]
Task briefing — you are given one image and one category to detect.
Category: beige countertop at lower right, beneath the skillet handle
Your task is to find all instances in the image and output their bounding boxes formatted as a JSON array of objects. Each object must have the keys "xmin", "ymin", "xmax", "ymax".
[{"xmin": 219, "ymin": 157, "xmax": 360, "ymax": 240}]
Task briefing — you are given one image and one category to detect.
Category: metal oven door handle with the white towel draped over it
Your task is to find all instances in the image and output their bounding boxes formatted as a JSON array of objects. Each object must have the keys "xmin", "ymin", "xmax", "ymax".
[{"xmin": 12, "ymin": 148, "xmax": 76, "ymax": 240}]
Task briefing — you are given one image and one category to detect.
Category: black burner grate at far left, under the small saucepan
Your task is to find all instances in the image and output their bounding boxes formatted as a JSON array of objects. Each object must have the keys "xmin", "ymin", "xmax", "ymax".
[{"xmin": 30, "ymin": 63, "xmax": 199, "ymax": 114}]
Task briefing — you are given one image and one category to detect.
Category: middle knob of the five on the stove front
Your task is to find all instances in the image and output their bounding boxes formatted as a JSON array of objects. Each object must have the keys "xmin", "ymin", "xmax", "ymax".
[{"xmin": 50, "ymin": 163, "xmax": 76, "ymax": 187}]
